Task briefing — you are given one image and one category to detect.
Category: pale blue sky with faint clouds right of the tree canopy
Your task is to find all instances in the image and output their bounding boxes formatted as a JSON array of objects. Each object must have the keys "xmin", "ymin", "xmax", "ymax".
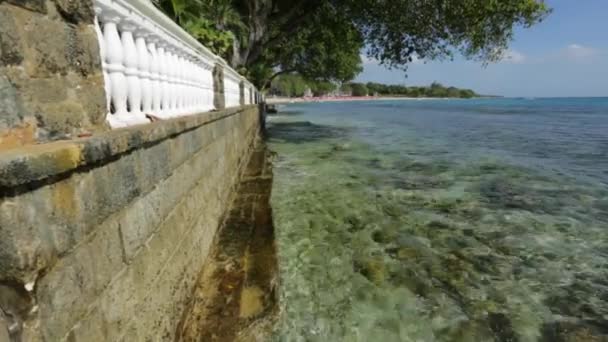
[{"xmin": 357, "ymin": 0, "xmax": 608, "ymax": 96}]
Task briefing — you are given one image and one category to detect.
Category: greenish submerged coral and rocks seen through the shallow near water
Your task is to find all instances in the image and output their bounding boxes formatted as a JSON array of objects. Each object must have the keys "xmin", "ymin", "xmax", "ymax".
[{"xmin": 270, "ymin": 113, "xmax": 608, "ymax": 341}]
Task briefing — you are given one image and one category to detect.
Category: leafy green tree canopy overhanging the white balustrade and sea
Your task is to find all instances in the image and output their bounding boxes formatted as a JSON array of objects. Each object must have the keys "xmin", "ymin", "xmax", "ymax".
[{"xmin": 154, "ymin": 0, "xmax": 550, "ymax": 86}]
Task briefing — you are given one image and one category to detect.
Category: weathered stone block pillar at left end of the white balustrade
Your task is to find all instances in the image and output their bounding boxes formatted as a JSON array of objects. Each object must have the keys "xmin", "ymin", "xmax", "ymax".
[{"xmin": 0, "ymin": 0, "xmax": 106, "ymax": 150}]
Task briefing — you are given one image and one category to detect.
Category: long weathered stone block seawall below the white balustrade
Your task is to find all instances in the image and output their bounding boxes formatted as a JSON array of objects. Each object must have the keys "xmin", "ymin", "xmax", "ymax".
[{"xmin": 0, "ymin": 105, "xmax": 260, "ymax": 341}]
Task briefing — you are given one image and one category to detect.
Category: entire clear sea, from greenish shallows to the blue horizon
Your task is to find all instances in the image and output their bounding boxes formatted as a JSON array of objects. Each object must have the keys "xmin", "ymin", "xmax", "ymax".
[{"xmin": 269, "ymin": 99, "xmax": 608, "ymax": 341}]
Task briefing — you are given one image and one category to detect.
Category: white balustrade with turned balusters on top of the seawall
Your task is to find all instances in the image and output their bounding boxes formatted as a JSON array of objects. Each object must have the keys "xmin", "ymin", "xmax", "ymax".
[{"xmin": 95, "ymin": 0, "xmax": 259, "ymax": 128}]
